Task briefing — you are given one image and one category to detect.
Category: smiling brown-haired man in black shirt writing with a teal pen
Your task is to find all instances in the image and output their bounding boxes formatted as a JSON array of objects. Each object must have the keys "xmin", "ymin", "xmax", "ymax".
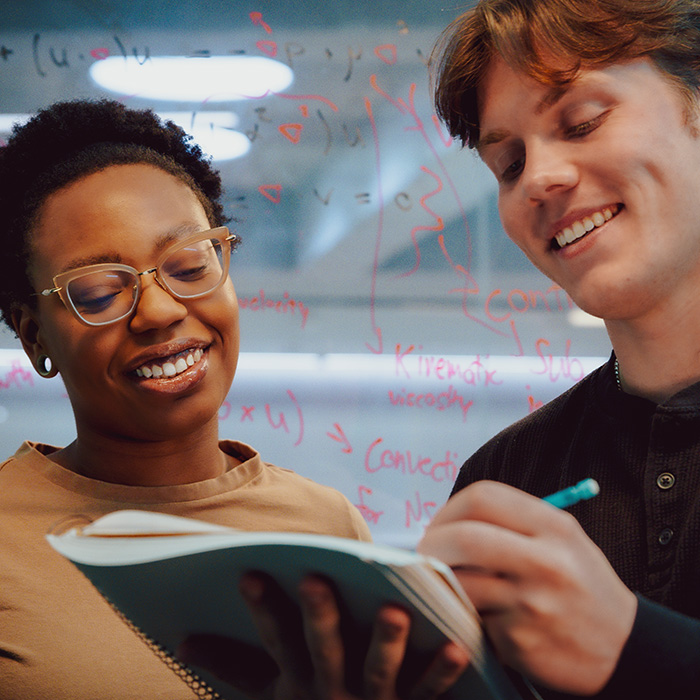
[{"xmin": 419, "ymin": 0, "xmax": 700, "ymax": 700}]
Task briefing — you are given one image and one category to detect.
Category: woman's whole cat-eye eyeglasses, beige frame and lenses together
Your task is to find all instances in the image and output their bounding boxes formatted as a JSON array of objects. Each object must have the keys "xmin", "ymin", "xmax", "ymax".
[{"xmin": 40, "ymin": 226, "xmax": 239, "ymax": 326}]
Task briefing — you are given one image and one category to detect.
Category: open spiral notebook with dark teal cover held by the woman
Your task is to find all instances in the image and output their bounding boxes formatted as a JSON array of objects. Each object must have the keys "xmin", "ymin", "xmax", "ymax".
[{"xmin": 47, "ymin": 510, "xmax": 521, "ymax": 700}]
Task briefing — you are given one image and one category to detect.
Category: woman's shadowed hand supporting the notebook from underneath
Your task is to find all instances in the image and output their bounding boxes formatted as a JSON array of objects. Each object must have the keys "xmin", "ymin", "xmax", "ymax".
[{"xmin": 179, "ymin": 574, "xmax": 468, "ymax": 700}]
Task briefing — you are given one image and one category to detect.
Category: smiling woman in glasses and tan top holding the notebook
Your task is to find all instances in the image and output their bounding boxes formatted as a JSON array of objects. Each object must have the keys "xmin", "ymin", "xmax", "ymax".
[{"xmin": 0, "ymin": 101, "xmax": 470, "ymax": 700}]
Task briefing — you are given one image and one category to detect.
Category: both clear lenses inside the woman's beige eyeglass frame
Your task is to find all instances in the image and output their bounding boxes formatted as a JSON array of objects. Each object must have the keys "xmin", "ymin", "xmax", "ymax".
[{"xmin": 66, "ymin": 239, "xmax": 227, "ymax": 324}]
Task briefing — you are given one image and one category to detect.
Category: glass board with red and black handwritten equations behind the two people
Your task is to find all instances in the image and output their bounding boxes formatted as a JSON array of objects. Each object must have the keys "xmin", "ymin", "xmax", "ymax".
[{"xmin": 0, "ymin": 0, "xmax": 610, "ymax": 546}]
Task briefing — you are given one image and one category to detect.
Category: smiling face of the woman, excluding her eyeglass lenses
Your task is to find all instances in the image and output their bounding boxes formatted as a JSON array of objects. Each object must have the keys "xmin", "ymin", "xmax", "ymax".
[{"xmin": 19, "ymin": 164, "xmax": 239, "ymax": 442}]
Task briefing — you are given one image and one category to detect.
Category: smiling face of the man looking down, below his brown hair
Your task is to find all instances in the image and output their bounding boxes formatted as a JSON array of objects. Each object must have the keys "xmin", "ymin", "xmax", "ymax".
[{"xmin": 478, "ymin": 59, "xmax": 700, "ymax": 321}]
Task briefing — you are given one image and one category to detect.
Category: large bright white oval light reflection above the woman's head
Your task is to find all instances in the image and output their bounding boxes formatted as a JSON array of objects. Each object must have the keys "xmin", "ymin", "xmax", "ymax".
[{"xmin": 90, "ymin": 56, "xmax": 294, "ymax": 103}]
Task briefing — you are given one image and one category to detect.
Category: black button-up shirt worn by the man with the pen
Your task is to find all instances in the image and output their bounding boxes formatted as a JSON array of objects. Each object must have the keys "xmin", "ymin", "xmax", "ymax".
[{"xmin": 453, "ymin": 359, "xmax": 700, "ymax": 700}]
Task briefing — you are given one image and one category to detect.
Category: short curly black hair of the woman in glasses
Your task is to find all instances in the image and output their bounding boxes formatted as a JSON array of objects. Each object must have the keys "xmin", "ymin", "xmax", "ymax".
[{"xmin": 0, "ymin": 100, "xmax": 227, "ymax": 328}]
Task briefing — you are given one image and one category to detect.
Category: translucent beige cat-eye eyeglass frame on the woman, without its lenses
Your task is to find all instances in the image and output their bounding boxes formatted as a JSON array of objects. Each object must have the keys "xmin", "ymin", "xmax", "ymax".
[{"xmin": 38, "ymin": 226, "xmax": 240, "ymax": 326}]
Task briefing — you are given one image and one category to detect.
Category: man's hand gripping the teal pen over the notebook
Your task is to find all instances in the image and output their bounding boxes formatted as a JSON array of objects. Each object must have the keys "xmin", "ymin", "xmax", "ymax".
[{"xmin": 418, "ymin": 481, "xmax": 637, "ymax": 695}]
